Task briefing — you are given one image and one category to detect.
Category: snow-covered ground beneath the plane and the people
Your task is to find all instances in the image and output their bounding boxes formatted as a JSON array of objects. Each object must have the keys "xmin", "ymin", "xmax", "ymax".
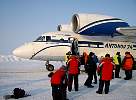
[{"xmin": 0, "ymin": 56, "xmax": 136, "ymax": 100}]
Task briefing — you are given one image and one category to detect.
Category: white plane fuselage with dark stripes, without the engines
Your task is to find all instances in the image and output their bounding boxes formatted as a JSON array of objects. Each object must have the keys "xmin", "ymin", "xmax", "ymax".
[{"xmin": 13, "ymin": 32, "xmax": 136, "ymax": 61}]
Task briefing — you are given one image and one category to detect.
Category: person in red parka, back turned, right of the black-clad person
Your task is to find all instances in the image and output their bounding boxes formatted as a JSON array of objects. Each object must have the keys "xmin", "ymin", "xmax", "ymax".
[{"xmin": 96, "ymin": 54, "xmax": 115, "ymax": 94}]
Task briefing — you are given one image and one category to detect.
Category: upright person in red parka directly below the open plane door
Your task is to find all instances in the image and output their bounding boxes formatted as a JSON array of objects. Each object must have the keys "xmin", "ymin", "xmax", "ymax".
[{"xmin": 67, "ymin": 55, "xmax": 80, "ymax": 92}]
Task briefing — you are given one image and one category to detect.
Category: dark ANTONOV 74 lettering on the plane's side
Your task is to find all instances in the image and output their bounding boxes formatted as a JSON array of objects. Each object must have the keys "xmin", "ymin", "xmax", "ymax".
[{"xmin": 105, "ymin": 43, "xmax": 133, "ymax": 49}]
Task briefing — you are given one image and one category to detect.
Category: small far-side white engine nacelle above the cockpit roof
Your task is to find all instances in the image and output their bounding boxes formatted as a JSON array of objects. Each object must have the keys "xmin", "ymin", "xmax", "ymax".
[{"xmin": 57, "ymin": 24, "xmax": 73, "ymax": 32}]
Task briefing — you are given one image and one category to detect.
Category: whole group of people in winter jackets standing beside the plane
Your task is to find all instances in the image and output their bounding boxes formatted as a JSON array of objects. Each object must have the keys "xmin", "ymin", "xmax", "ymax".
[{"xmin": 48, "ymin": 52, "xmax": 134, "ymax": 100}]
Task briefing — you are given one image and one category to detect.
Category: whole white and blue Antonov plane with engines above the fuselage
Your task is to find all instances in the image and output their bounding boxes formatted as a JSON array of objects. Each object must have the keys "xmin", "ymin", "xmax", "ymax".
[{"xmin": 13, "ymin": 14, "xmax": 136, "ymax": 70}]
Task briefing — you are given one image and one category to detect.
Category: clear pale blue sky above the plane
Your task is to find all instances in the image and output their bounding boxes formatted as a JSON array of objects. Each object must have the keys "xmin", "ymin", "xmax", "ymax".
[{"xmin": 0, "ymin": 0, "xmax": 136, "ymax": 54}]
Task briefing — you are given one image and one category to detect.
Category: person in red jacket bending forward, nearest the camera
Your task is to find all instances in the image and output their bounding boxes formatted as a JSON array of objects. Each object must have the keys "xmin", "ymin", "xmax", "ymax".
[{"xmin": 48, "ymin": 65, "xmax": 68, "ymax": 100}]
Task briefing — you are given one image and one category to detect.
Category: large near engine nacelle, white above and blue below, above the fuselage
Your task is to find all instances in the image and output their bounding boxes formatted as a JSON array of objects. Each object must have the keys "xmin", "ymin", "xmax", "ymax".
[{"xmin": 72, "ymin": 14, "xmax": 129, "ymax": 36}]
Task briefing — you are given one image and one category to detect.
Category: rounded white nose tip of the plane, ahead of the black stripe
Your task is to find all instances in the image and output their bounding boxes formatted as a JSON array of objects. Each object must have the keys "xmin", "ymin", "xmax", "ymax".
[{"xmin": 12, "ymin": 44, "xmax": 33, "ymax": 59}]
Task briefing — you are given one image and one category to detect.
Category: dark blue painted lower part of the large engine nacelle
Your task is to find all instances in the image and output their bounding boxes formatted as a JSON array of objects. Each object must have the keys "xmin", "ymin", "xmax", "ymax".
[{"xmin": 79, "ymin": 22, "xmax": 129, "ymax": 36}]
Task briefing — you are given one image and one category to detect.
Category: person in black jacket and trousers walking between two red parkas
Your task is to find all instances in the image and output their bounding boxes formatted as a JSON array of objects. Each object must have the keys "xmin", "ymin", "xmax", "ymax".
[{"xmin": 84, "ymin": 52, "xmax": 97, "ymax": 88}]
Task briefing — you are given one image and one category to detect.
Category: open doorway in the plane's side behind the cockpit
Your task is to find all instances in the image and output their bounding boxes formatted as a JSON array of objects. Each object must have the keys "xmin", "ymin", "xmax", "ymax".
[{"xmin": 69, "ymin": 37, "xmax": 79, "ymax": 55}]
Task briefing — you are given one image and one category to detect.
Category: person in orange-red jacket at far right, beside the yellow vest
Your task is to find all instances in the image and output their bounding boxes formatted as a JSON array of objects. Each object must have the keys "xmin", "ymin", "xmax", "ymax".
[{"xmin": 122, "ymin": 52, "xmax": 134, "ymax": 80}]
